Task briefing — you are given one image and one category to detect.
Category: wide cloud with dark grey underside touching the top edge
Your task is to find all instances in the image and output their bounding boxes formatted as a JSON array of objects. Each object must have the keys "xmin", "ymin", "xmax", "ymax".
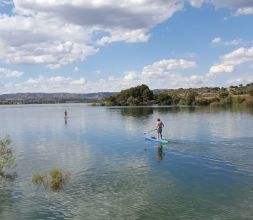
[{"xmin": 14, "ymin": 0, "xmax": 183, "ymax": 30}]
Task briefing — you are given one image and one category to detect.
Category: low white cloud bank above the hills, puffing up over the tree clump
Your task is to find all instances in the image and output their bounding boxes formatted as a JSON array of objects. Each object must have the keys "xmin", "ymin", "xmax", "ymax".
[{"xmin": 0, "ymin": 59, "xmax": 202, "ymax": 93}]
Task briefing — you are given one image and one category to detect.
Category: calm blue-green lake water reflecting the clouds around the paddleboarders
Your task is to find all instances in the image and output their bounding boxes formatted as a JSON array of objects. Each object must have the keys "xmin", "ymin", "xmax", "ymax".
[{"xmin": 0, "ymin": 104, "xmax": 253, "ymax": 220}]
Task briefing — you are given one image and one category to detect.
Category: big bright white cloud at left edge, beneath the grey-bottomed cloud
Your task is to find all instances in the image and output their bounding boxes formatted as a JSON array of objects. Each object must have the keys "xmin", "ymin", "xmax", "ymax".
[{"xmin": 0, "ymin": 15, "xmax": 97, "ymax": 68}]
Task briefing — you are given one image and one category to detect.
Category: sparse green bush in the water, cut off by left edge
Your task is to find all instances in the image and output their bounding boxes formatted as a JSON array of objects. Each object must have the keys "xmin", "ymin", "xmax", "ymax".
[{"xmin": 0, "ymin": 137, "xmax": 16, "ymax": 179}]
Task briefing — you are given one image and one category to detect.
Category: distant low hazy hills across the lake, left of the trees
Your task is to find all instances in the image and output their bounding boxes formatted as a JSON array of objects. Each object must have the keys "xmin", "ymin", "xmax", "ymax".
[{"xmin": 0, "ymin": 92, "xmax": 115, "ymax": 104}]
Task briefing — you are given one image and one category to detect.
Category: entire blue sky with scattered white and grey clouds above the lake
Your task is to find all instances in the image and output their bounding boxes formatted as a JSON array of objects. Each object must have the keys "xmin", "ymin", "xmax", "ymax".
[{"xmin": 0, "ymin": 0, "xmax": 253, "ymax": 94}]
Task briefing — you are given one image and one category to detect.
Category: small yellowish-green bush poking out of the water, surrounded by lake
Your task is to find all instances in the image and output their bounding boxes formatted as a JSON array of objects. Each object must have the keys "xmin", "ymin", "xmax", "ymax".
[{"xmin": 32, "ymin": 168, "xmax": 70, "ymax": 191}]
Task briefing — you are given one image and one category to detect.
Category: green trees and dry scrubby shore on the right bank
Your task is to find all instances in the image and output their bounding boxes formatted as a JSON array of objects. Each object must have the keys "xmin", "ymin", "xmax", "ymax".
[{"xmin": 97, "ymin": 83, "xmax": 253, "ymax": 108}]
